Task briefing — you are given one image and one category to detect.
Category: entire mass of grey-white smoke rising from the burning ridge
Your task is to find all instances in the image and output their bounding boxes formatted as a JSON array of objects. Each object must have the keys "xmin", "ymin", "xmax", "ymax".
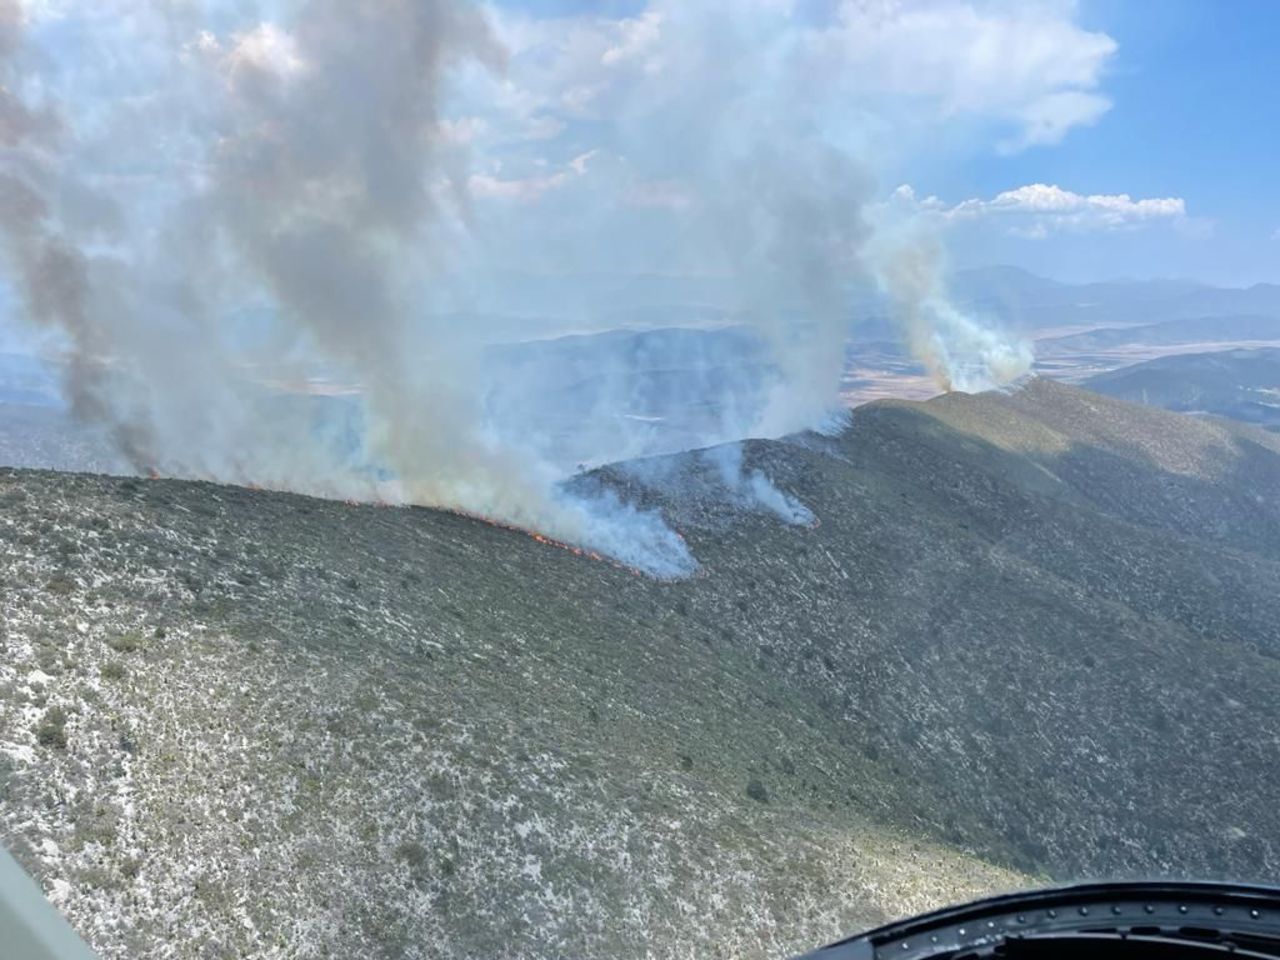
[{"xmin": 0, "ymin": 0, "xmax": 1039, "ymax": 575}]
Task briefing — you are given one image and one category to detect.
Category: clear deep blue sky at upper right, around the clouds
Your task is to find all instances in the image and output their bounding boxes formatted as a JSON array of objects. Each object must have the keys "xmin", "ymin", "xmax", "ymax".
[{"xmin": 915, "ymin": 0, "xmax": 1280, "ymax": 284}]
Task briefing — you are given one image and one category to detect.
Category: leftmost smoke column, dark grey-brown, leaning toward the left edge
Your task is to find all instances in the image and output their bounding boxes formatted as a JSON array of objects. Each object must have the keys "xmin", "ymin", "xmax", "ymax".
[{"xmin": 0, "ymin": 0, "xmax": 369, "ymax": 495}]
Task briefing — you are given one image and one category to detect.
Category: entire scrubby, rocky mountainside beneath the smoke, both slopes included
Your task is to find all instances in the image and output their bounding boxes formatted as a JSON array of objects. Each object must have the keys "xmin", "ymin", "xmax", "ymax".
[{"xmin": 0, "ymin": 380, "xmax": 1280, "ymax": 957}]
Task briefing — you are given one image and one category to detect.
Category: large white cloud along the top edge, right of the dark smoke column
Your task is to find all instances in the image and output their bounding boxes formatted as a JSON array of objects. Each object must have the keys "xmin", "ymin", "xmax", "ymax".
[{"xmin": 476, "ymin": 0, "xmax": 1117, "ymax": 165}]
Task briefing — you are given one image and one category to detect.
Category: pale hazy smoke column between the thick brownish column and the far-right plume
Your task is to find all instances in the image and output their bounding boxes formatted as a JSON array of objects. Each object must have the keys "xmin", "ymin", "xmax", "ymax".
[{"xmin": 593, "ymin": 3, "xmax": 876, "ymax": 443}]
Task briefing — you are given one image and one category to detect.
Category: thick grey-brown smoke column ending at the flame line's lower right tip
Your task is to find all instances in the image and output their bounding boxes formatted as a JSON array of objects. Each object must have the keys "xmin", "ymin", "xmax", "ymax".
[{"xmin": 200, "ymin": 0, "xmax": 689, "ymax": 573}]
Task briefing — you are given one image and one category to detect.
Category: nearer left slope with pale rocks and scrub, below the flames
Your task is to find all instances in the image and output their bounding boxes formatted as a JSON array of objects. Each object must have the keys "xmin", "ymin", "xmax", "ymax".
[{"xmin": 0, "ymin": 472, "xmax": 1027, "ymax": 957}]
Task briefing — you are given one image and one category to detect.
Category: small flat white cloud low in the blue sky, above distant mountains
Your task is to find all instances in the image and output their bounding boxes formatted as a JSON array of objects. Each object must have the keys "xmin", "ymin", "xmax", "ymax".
[{"xmin": 892, "ymin": 183, "xmax": 1187, "ymax": 238}]
